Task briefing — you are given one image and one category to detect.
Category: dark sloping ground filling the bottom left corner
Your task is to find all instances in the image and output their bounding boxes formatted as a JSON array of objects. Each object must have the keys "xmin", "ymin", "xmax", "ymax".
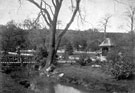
[{"xmin": 0, "ymin": 72, "xmax": 34, "ymax": 93}]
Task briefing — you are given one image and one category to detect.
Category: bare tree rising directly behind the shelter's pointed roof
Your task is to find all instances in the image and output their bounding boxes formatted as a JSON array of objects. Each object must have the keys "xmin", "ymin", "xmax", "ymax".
[{"xmin": 100, "ymin": 14, "xmax": 112, "ymax": 39}]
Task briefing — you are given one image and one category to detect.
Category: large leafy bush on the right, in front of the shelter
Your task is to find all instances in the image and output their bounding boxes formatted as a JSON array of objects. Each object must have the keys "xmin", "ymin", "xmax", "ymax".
[{"xmin": 107, "ymin": 51, "xmax": 134, "ymax": 80}]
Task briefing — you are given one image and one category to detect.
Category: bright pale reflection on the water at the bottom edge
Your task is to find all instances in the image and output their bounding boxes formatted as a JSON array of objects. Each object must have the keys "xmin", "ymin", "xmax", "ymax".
[{"xmin": 54, "ymin": 84, "xmax": 86, "ymax": 93}]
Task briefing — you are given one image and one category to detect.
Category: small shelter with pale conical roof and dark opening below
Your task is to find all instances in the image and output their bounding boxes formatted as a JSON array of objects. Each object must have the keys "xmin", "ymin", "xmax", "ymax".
[{"xmin": 99, "ymin": 38, "xmax": 114, "ymax": 56}]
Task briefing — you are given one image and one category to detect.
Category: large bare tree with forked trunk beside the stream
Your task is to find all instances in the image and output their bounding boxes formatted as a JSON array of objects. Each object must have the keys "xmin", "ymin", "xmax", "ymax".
[{"xmin": 19, "ymin": 0, "xmax": 81, "ymax": 68}]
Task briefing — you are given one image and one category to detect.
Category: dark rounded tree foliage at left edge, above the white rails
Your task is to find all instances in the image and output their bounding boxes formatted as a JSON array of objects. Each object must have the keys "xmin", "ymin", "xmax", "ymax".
[{"xmin": 1, "ymin": 24, "xmax": 29, "ymax": 51}]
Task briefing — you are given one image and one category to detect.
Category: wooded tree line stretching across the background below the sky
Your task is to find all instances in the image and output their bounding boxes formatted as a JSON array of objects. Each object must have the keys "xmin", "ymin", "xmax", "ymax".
[{"xmin": 0, "ymin": 22, "xmax": 135, "ymax": 54}]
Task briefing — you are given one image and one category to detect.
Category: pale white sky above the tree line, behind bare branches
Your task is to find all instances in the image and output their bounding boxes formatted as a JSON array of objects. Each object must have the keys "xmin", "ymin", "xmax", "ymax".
[{"xmin": 0, "ymin": 0, "xmax": 135, "ymax": 32}]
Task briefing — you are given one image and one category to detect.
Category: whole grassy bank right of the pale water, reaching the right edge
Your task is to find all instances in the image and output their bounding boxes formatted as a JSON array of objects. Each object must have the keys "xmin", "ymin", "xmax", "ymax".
[{"xmin": 56, "ymin": 65, "xmax": 135, "ymax": 93}]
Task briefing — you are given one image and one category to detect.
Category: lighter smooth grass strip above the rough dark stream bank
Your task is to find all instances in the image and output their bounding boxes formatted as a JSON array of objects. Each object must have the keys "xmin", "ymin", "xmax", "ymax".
[{"xmin": 56, "ymin": 65, "xmax": 112, "ymax": 81}]
